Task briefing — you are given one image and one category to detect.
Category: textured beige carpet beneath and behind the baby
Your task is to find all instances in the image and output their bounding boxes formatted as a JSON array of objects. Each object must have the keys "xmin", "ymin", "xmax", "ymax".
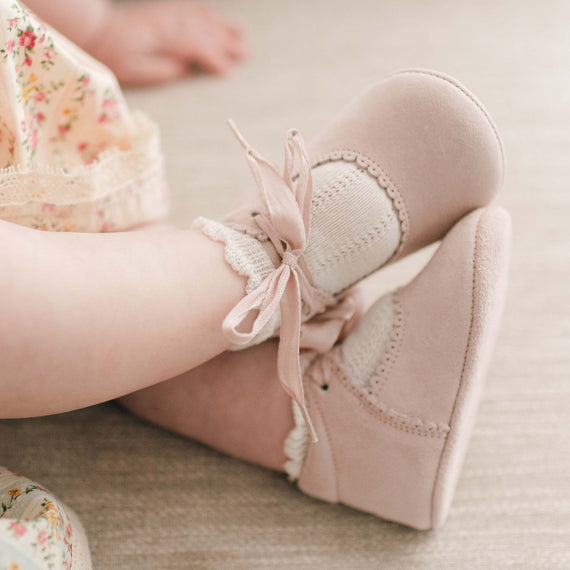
[{"xmin": 0, "ymin": 0, "xmax": 570, "ymax": 570}]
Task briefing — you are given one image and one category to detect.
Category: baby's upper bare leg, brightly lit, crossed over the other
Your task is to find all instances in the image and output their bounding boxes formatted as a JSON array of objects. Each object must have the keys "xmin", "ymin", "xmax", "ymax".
[{"xmin": 0, "ymin": 221, "xmax": 245, "ymax": 418}]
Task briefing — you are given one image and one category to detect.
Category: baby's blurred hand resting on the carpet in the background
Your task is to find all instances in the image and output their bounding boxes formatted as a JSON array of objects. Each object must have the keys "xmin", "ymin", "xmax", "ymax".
[{"xmin": 86, "ymin": 0, "xmax": 246, "ymax": 85}]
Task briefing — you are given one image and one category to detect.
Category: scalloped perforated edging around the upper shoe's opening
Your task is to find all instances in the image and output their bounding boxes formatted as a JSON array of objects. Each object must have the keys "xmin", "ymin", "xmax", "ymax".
[{"xmin": 311, "ymin": 149, "xmax": 410, "ymax": 263}]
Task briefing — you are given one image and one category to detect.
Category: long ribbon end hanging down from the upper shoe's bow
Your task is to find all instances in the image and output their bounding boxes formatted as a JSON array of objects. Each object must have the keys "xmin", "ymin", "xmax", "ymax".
[{"xmin": 277, "ymin": 271, "xmax": 319, "ymax": 443}]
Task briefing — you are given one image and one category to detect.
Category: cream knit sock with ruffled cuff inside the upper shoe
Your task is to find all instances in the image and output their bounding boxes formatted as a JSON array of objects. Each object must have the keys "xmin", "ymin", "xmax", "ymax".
[{"xmin": 194, "ymin": 160, "xmax": 401, "ymax": 342}]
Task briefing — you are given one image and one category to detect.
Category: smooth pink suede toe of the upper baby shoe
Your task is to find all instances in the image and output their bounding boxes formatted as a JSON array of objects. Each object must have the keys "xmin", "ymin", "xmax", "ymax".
[{"xmin": 309, "ymin": 70, "xmax": 504, "ymax": 260}]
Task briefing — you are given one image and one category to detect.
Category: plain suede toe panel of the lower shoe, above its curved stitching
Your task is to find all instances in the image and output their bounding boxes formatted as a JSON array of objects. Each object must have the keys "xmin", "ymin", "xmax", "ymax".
[{"xmin": 378, "ymin": 210, "xmax": 481, "ymax": 423}]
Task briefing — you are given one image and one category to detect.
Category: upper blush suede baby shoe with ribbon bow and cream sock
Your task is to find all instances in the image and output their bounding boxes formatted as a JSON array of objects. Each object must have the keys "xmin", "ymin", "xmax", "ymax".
[{"xmin": 194, "ymin": 71, "xmax": 503, "ymax": 439}]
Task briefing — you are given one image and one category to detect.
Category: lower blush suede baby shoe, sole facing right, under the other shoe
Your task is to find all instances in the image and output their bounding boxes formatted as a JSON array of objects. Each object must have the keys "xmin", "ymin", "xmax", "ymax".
[{"xmin": 285, "ymin": 207, "xmax": 510, "ymax": 529}]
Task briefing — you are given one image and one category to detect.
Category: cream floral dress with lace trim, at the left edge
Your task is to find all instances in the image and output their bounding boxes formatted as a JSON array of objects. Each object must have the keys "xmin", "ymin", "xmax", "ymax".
[{"xmin": 0, "ymin": 0, "xmax": 169, "ymax": 570}]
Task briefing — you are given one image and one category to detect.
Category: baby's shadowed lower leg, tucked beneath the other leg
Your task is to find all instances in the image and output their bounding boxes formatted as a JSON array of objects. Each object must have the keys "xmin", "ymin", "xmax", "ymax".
[{"xmin": 120, "ymin": 341, "xmax": 294, "ymax": 471}]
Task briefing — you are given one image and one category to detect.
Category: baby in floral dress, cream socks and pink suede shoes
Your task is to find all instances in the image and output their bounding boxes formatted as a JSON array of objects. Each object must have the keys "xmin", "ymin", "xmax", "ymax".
[{"xmin": 0, "ymin": 0, "xmax": 509, "ymax": 567}]
